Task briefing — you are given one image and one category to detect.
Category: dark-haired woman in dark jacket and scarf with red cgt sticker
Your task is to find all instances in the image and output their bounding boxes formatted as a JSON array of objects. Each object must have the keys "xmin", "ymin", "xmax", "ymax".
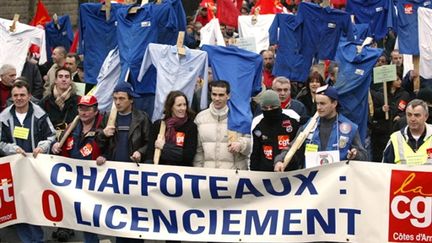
[{"xmin": 147, "ymin": 91, "xmax": 198, "ymax": 166}]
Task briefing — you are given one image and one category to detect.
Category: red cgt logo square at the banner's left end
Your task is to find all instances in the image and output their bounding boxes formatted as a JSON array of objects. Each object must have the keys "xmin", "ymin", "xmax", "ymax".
[{"xmin": 0, "ymin": 163, "xmax": 16, "ymax": 224}]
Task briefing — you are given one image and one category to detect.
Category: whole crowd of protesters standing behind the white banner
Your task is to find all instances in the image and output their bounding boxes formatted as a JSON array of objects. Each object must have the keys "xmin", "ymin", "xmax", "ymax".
[{"xmin": 0, "ymin": 1, "xmax": 432, "ymax": 242}]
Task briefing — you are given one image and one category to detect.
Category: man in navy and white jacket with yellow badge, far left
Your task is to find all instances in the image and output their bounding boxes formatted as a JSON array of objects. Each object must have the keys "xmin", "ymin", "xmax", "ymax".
[{"xmin": 0, "ymin": 80, "xmax": 55, "ymax": 242}]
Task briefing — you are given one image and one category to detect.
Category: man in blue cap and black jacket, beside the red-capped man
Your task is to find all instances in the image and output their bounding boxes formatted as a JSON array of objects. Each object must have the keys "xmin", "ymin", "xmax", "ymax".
[{"xmin": 96, "ymin": 81, "xmax": 150, "ymax": 165}]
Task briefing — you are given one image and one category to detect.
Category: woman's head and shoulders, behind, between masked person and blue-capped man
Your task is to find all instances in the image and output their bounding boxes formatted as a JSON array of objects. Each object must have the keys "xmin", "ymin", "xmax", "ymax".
[{"xmin": 297, "ymin": 71, "xmax": 325, "ymax": 117}]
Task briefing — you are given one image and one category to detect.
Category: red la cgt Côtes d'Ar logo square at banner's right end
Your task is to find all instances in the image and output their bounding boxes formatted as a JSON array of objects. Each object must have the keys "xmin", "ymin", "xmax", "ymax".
[{"xmin": 388, "ymin": 170, "xmax": 432, "ymax": 242}]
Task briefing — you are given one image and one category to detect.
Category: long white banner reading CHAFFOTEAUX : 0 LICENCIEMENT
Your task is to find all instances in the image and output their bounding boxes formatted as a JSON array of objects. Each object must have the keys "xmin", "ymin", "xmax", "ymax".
[{"xmin": 0, "ymin": 154, "xmax": 432, "ymax": 243}]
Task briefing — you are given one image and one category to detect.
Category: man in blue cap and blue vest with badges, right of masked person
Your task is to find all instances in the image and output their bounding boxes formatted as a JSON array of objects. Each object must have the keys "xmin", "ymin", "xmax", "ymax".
[{"xmin": 274, "ymin": 85, "xmax": 367, "ymax": 171}]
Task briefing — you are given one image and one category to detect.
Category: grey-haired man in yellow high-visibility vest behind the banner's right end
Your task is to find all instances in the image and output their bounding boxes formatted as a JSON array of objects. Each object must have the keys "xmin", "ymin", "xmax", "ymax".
[{"xmin": 383, "ymin": 99, "xmax": 432, "ymax": 165}]
